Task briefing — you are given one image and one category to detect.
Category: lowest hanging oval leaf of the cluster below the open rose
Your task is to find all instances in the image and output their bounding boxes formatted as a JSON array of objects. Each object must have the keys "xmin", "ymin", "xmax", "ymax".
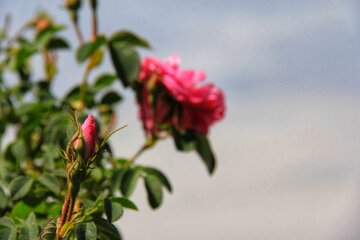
[{"xmin": 144, "ymin": 175, "xmax": 163, "ymax": 209}]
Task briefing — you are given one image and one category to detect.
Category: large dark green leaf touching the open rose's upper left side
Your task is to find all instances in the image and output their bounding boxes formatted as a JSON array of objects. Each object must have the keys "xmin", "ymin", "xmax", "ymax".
[{"xmin": 108, "ymin": 42, "xmax": 140, "ymax": 87}]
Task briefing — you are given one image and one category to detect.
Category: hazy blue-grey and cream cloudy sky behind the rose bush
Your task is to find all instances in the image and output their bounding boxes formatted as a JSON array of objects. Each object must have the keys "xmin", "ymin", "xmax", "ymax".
[{"xmin": 0, "ymin": 0, "xmax": 360, "ymax": 240}]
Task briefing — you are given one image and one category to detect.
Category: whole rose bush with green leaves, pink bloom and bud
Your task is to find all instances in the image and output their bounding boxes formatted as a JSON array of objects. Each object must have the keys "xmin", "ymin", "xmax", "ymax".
[{"xmin": 0, "ymin": 0, "xmax": 225, "ymax": 240}]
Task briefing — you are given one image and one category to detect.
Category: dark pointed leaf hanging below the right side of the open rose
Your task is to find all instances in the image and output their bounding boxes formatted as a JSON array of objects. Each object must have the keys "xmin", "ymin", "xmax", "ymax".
[{"xmin": 196, "ymin": 133, "xmax": 216, "ymax": 174}]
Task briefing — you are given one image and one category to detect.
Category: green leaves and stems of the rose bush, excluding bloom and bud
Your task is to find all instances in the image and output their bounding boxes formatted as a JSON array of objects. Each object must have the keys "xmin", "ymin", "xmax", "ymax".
[{"xmin": 0, "ymin": 0, "xmax": 224, "ymax": 240}]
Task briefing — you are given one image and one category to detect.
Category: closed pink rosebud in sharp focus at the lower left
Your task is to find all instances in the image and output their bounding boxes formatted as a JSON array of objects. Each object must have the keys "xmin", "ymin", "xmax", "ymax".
[{"xmin": 74, "ymin": 114, "xmax": 97, "ymax": 159}]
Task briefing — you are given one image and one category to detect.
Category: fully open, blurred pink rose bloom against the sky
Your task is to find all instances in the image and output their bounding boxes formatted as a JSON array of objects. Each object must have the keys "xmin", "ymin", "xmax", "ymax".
[{"xmin": 139, "ymin": 55, "xmax": 225, "ymax": 134}]
